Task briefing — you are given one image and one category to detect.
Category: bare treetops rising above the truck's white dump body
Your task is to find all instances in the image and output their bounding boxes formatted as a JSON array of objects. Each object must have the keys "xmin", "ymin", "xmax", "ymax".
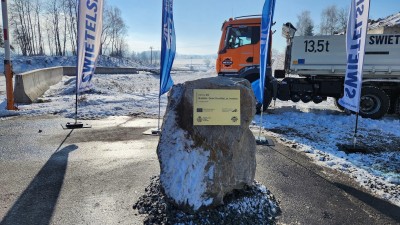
[{"xmin": 296, "ymin": 5, "xmax": 348, "ymax": 36}]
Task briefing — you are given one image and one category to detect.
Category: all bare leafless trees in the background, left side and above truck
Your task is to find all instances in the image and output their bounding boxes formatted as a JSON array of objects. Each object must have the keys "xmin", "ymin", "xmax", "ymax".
[{"xmin": 0, "ymin": 0, "xmax": 376, "ymax": 57}]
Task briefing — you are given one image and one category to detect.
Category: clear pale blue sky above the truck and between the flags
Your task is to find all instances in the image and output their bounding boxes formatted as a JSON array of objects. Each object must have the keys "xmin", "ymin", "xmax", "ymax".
[{"xmin": 107, "ymin": 0, "xmax": 400, "ymax": 54}]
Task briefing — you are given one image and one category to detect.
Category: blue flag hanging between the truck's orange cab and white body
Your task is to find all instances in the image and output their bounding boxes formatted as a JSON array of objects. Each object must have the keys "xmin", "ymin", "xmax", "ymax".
[{"xmin": 252, "ymin": 0, "xmax": 275, "ymax": 103}]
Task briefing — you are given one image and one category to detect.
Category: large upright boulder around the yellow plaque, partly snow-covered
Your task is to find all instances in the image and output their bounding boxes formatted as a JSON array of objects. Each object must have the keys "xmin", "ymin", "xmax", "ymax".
[{"xmin": 157, "ymin": 77, "xmax": 256, "ymax": 210}]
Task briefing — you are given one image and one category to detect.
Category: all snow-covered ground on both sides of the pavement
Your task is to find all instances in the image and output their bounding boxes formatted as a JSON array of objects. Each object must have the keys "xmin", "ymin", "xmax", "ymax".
[{"xmin": 0, "ymin": 56, "xmax": 400, "ymax": 206}]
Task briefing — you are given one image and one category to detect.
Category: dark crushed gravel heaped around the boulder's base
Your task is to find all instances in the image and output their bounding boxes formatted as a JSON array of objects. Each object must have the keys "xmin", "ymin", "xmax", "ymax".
[{"xmin": 133, "ymin": 176, "xmax": 281, "ymax": 225}]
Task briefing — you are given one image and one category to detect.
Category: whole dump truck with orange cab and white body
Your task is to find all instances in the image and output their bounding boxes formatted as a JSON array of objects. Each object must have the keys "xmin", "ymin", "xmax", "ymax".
[{"xmin": 216, "ymin": 16, "xmax": 400, "ymax": 119}]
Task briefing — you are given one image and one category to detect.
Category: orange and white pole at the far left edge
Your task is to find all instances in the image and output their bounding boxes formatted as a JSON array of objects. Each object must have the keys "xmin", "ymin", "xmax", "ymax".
[{"xmin": 1, "ymin": 0, "xmax": 17, "ymax": 110}]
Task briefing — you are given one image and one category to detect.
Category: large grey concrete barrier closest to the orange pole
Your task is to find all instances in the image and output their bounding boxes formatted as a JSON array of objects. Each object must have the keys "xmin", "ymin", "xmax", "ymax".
[{"xmin": 14, "ymin": 67, "xmax": 63, "ymax": 104}]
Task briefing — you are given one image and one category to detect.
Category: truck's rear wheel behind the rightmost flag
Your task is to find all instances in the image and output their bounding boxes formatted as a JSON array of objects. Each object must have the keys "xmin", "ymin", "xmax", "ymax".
[{"xmin": 360, "ymin": 86, "xmax": 390, "ymax": 119}]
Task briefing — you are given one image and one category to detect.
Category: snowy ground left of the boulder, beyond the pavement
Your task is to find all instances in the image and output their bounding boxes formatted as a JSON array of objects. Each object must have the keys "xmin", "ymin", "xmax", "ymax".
[{"xmin": 0, "ymin": 72, "xmax": 212, "ymax": 119}]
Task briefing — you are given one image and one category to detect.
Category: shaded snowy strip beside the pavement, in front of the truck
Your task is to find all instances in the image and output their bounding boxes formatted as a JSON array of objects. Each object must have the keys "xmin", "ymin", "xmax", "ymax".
[{"xmin": 254, "ymin": 99, "xmax": 400, "ymax": 206}]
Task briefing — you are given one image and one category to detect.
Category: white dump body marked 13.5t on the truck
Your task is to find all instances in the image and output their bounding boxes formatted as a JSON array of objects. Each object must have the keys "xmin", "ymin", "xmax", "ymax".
[{"xmin": 290, "ymin": 34, "xmax": 400, "ymax": 79}]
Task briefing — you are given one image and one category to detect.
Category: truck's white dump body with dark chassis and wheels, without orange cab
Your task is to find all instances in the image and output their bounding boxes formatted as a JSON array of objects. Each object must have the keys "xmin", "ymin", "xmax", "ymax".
[{"xmin": 275, "ymin": 23, "xmax": 400, "ymax": 119}]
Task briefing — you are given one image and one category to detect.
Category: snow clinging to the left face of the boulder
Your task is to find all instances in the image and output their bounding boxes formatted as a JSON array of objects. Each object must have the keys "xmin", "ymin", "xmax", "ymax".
[{"xmin": 157, "ymin": 85, "xmax": 214, "ymax": 210}]
